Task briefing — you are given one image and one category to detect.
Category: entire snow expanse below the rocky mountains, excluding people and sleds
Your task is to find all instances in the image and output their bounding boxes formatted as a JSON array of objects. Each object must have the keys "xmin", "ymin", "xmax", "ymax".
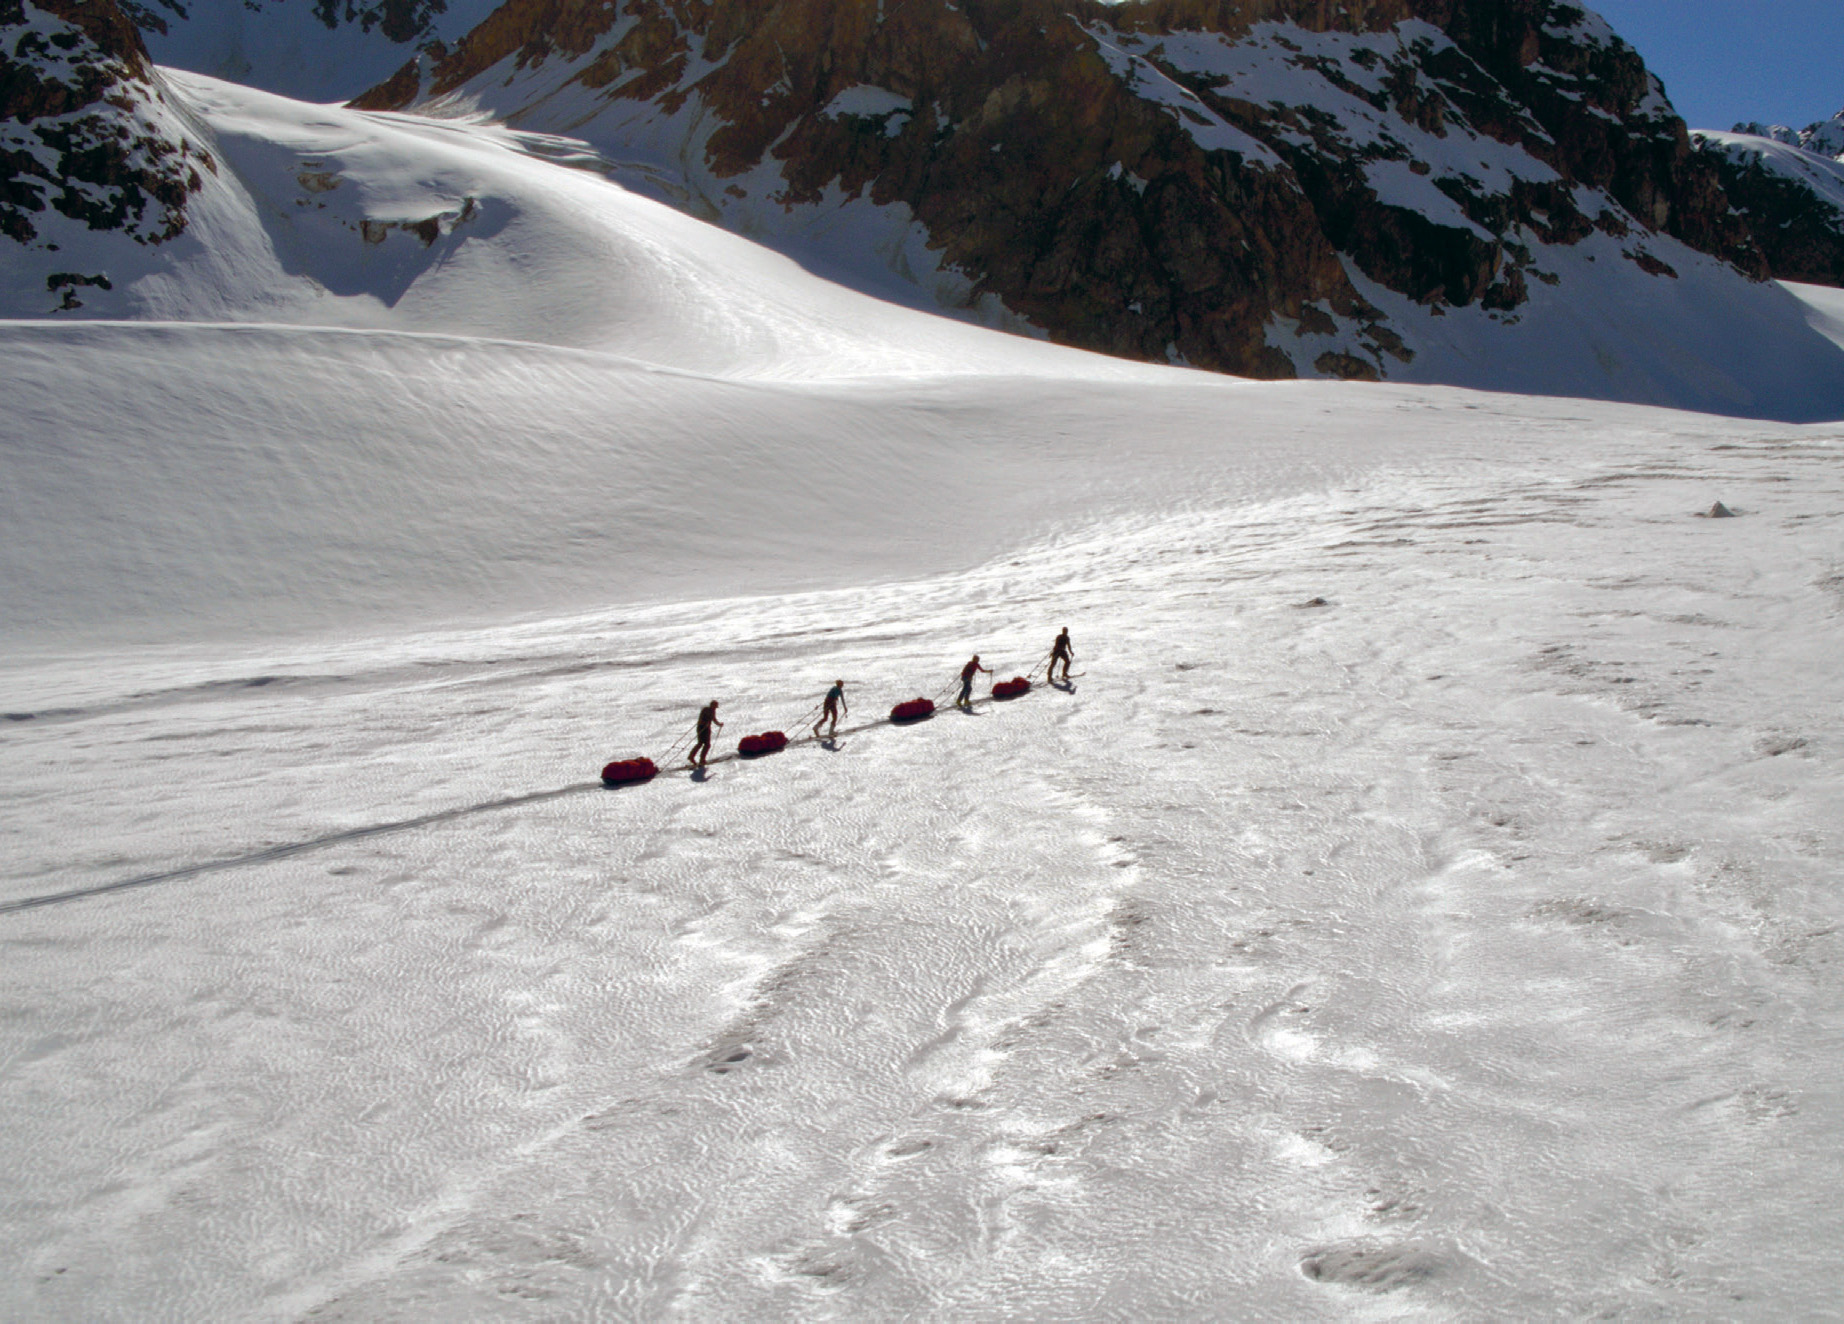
[{"xmin": 0, "ymin": 17, "xmax": 1844, "ymax": 1320}]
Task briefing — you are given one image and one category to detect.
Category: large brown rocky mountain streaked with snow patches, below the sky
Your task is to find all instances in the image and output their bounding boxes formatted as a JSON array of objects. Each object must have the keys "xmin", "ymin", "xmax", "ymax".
[{"xmin": 360, "ymin": 0, "xmax": 1768, "ymax": 378}]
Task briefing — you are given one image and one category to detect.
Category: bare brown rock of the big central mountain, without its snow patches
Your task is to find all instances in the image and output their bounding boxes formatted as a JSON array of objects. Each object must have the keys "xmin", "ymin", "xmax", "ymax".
[{"xmin": 356, "ymin": 0, "xmax": 1767, "ymax": 376}]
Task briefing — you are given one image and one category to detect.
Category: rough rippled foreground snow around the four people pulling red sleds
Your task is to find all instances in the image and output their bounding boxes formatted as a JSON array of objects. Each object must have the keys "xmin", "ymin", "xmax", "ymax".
[{"xmin": 0, "ymin": 420, "xmax": 1844, "ymax": 1320}]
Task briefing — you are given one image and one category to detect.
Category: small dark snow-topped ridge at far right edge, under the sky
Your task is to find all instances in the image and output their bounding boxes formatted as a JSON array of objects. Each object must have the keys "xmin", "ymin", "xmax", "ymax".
[{"xmin": 1696, "ymin": 122, "xmax": 1844, "ymax": 286}]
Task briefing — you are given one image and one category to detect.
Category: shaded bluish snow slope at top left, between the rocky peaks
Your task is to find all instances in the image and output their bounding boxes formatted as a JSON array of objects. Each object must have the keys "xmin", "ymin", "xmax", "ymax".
[{"xmin": 122, "ymin": 0, "xmax": 494, "ymax": 101}]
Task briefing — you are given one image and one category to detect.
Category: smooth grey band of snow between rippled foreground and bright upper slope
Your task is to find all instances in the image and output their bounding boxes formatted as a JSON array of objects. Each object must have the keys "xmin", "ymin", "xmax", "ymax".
[{"xmin": 0, "ymin": 319, "xmax": 1689, "ymax": 649}]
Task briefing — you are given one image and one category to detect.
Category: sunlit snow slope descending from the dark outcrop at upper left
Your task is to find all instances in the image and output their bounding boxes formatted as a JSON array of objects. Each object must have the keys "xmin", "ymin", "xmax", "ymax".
[{"xmin": 0, "ymin": 72, "xmax": 1165, "ymax": 376}]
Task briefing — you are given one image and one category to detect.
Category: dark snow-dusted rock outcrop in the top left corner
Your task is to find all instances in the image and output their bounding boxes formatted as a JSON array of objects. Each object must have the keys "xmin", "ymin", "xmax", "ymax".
[{"xmin": 0, "ymin": 0, "xmax": 214, "ymax": 269}]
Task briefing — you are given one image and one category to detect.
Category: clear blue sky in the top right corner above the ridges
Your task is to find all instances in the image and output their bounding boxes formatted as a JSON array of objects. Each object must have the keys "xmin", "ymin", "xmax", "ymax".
[{"xmin": 1577, "ymin": 0, "xmax": 1844, "ymax": 129}]
